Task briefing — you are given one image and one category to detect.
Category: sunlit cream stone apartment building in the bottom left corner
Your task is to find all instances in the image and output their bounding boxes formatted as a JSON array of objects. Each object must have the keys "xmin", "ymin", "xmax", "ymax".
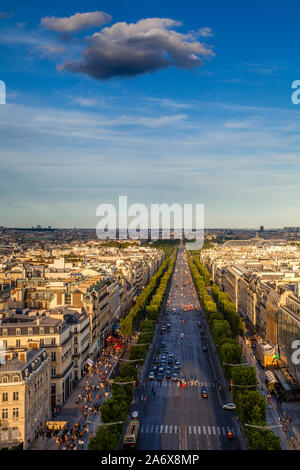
[{"xmin": 0, "ymin": 348, "xmax": 51, "ymax": 449}]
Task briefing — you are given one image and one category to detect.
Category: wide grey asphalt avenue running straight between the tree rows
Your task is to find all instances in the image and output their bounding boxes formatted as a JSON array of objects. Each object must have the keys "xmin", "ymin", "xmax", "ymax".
[{"xmin": 132, "ymin": 248, "xmax": 242, "ymax": 450}]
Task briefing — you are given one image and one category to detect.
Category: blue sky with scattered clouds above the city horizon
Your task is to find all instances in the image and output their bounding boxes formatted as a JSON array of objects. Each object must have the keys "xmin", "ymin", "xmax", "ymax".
[{"xmin": 0, "ymin": 0, "xmax": 300, "ymax": 228}]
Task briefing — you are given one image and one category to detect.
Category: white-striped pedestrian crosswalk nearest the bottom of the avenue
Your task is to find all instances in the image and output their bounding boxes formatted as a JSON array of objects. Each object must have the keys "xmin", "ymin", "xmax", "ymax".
[{"xmin": 140, "ymin": 424, "xmax": 234, "ymax": 436}]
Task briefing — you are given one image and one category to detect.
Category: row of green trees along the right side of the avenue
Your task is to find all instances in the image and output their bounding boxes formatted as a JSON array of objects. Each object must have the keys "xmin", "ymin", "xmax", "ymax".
[{"xmin": 188, "ymin": 252, "xmax": 281, "ymax": 450}]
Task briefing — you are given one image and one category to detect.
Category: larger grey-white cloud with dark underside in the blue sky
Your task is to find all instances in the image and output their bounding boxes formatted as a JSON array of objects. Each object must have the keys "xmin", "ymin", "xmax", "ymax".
[{"xmin": 58, "ymin": 18, "xmax": 215, "ymax": 80}]
